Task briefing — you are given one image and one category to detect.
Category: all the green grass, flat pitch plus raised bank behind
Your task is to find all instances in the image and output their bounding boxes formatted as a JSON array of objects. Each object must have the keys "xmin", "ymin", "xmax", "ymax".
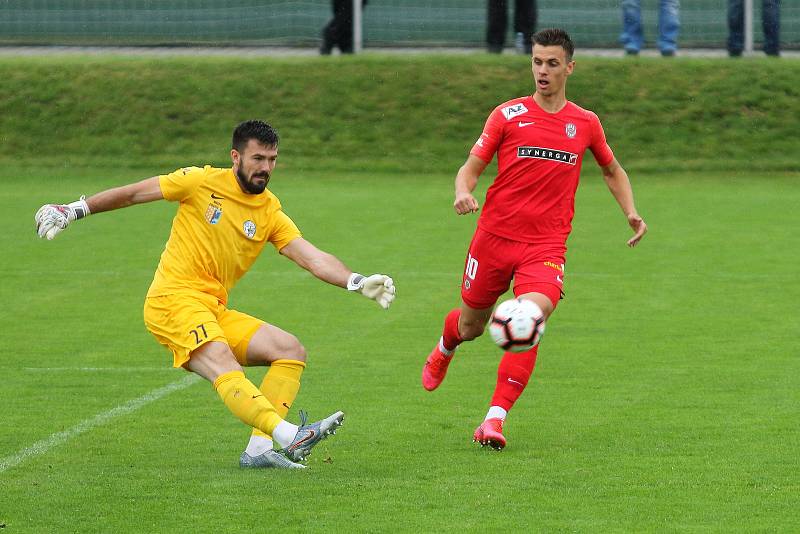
[{"xmin": 0, "ymin": 55, "xmax": 800, "ymax": 533}]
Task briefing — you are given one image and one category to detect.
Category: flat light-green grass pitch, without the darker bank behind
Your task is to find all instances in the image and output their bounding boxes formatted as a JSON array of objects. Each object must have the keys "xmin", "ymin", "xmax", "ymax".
[{"xmin": 0, "ymin": 166, "xmax": 800, "ymax": 533}]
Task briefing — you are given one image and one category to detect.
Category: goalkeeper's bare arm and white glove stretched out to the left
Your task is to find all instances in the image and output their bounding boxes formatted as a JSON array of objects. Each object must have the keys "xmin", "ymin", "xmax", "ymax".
[{"xmin": 33, "ymin": 176, "xmax": 164, "ymax": 240}]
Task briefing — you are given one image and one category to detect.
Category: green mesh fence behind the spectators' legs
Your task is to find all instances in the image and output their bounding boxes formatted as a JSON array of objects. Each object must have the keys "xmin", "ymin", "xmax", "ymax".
[{"xmin": 0, "ymin": 0, "xmax": 800, "ymax": 49}]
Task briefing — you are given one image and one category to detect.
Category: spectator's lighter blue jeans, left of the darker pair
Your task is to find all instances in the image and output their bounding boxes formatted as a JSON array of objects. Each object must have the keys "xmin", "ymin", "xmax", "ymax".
[{"xmin": 620, "ymin": 0, "xmax": 681, "ymax": 53}]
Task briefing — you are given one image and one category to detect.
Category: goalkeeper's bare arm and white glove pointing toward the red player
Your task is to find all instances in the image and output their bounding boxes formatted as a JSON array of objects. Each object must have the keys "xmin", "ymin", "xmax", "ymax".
[{"xmin": 281, "ymin": 237, "xmax": 395, "ymax": 309}]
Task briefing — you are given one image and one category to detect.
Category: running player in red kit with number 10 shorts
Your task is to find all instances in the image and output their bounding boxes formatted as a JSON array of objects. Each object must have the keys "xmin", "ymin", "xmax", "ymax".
[{"xmin": 422, "ymin": 29, "xmax": 647, "ymax": 450}]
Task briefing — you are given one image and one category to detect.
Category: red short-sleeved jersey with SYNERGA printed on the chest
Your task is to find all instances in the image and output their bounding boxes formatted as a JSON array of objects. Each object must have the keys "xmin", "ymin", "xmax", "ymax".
[{"xmin": 470, "ymin": 96, "xmax": 614, "ymax": 246}]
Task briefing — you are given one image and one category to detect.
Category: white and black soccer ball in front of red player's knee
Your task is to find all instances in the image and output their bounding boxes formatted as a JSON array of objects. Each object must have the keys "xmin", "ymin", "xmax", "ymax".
[{"xmin": 489, "ymin": 299, "xmax": 544, "ymax": 352}]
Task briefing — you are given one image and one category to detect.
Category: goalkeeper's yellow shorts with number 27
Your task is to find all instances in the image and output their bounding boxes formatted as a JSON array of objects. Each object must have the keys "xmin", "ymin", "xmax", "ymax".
[{"xmin": 144, "ymin": 292, "xmax": 264, "ymax": 367}]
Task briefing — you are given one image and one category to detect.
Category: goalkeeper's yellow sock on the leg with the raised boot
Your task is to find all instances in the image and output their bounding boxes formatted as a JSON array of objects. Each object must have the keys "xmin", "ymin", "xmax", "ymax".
[{"xmin": 214, "ymin": 371, "xmax": 285, "ymax": 434}]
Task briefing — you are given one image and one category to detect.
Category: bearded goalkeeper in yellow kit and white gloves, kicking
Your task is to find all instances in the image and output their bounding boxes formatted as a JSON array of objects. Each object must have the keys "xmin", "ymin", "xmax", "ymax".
[{"xmin": 35, "ymin": 120, "xmax": 395, "ymax": 468}]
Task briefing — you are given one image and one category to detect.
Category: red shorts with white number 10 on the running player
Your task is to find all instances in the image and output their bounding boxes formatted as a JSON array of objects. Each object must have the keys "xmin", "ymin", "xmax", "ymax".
[{"xmin": 461, "ymin": 228, "xmax": 567, "ymax": 309}]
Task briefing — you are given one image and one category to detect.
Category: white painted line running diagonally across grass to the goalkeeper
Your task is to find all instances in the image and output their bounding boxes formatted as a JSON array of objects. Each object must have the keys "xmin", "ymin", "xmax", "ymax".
[{"xmin": 0, "ymin": 375, "xmax": 200, "ymax": 473}]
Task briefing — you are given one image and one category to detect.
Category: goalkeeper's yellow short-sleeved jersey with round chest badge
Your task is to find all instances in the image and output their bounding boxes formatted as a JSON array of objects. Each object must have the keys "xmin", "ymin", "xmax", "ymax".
[{"xmin": 147, "ymin": 165, "xmax": 301, "ymax": 304}]
